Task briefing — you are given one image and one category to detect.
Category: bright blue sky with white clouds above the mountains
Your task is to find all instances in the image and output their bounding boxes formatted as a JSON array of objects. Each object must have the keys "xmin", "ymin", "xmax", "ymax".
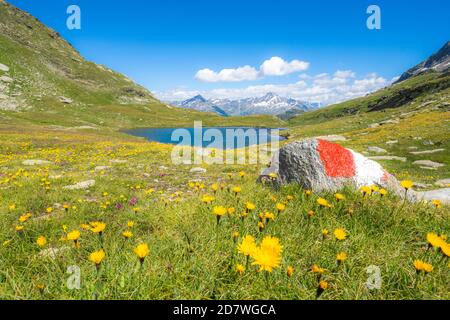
[{"xmin": 9, "ymin": 0, "xmax": 450, "ymax": 103}]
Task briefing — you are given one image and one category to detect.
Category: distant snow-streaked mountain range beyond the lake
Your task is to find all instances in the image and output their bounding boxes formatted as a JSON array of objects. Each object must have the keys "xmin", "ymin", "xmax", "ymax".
[{"xmin": 171, "ymin": 92, "xmax": 321, "ymax": 118}]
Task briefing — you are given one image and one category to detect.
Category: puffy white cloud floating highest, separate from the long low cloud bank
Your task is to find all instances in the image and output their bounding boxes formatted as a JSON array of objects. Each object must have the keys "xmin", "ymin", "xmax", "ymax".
[{"xmin": 195, "ymin": 57, "xmax": 309, "ymax": 82}]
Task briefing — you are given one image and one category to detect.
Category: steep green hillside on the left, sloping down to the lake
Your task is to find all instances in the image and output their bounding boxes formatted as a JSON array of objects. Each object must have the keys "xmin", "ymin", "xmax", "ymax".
[{"xmin": 0, "ymin": 2, "xmax": 282, "ymax": 131}]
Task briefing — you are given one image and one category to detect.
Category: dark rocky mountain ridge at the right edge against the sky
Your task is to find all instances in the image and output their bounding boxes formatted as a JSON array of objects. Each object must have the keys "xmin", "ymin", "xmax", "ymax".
[{"xmin": 397, "ymin": 41, "xmax": 450, "ymax": 82}]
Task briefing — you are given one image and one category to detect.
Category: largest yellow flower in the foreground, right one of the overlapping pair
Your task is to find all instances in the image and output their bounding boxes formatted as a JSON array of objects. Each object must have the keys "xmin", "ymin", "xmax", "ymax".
[{"xmin": 252, "ymin": 236, "xmax": 283, "ymax": 272}]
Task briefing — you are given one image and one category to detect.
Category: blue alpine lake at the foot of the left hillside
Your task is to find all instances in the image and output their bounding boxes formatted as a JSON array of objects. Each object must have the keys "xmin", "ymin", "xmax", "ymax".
[{"xmin": 125, "ymin": 127, "xmax": 285, "ymax": 149}]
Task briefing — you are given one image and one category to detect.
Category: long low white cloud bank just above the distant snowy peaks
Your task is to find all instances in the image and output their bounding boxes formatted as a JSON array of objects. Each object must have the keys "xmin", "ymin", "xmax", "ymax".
[{"xmin": 156, "ymin": 71, "xmax": 392, "ymax": 105}]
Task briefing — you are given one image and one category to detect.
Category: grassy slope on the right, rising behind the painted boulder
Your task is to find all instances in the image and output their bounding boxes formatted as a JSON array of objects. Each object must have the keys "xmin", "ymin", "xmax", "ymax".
[{"xmin": 289, "ymin": 74, "xmax": 450, "ymax": 184}]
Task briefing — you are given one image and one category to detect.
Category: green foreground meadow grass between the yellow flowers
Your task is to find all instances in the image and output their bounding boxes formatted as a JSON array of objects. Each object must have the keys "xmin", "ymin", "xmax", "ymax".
[{"xmin": 0, "ymin": 132, "xmax": 450, "ymax": 299}]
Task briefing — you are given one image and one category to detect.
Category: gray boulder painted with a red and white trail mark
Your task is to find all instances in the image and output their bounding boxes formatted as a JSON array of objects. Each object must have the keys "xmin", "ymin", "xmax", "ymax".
[{"xmin": 259, "ymin": 139, "xmax": 404, "ymax": 195}]
